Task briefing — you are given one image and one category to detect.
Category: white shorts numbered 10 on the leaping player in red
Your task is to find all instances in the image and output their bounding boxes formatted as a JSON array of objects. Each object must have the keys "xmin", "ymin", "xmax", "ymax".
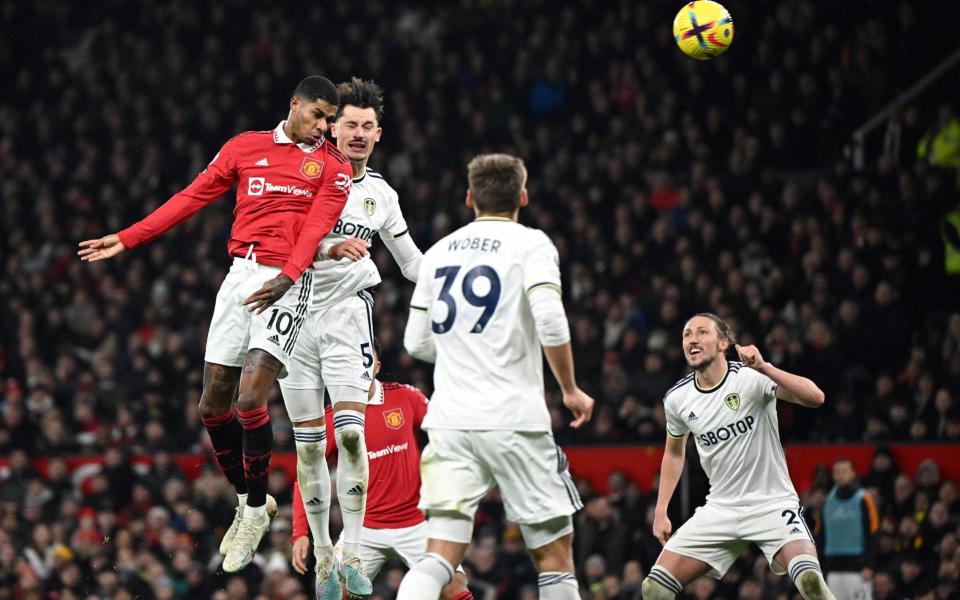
[{"xmin": 204, "ymin": 257, "xmax": 313, "ymax": 378}]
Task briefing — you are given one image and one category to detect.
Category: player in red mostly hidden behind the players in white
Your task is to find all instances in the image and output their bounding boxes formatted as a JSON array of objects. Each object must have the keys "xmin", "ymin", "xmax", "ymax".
[{"xmin": 291, "ymin": 344, "xmax": 473, "ymax": 600}]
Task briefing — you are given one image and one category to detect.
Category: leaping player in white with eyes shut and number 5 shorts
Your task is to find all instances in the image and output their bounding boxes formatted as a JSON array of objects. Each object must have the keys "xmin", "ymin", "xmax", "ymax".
[{"xmin": 280, "ymin": 77, "xmax": 423, "ymax": 598}]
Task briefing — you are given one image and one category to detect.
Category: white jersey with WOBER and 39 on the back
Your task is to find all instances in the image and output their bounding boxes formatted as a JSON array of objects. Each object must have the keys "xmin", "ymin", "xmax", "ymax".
[{"xmin": 410, "ymin": 217, "xmax": 560, "ymax": 431}]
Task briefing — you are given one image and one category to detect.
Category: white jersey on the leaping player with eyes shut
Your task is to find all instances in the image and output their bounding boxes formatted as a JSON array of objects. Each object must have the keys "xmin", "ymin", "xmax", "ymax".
[{"xmin": 313, "ymin": 168, "xmax": 409, "ymax": 306}]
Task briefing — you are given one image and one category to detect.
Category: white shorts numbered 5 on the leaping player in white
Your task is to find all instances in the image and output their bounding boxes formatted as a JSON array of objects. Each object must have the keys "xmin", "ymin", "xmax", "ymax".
[{"xmin": 280, "ymin": 291, "xmax": 374, "ymax": 423}]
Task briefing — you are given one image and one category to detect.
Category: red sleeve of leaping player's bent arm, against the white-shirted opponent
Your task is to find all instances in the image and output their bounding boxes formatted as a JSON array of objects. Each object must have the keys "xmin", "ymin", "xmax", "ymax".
[{"xmin": 281, "ymin": 157, "xmax": 353, "ymax": 281}]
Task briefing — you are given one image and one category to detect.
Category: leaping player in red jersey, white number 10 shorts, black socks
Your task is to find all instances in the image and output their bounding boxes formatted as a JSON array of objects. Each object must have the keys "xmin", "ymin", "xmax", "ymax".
[{"xmin": 78, "ymin": 77, "xmax": 351, "ymax": 572}]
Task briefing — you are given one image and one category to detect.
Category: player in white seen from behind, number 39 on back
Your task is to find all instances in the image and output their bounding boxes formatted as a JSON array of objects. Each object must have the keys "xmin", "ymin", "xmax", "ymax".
[{"xmin": 397, "ymin": 154, "xmax": 593, "ymax": 600}]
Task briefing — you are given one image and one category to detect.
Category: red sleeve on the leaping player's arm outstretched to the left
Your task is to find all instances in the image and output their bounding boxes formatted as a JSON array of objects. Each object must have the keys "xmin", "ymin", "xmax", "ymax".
[{"xmin": 119, "ymin": 138, "xmax": 237, "ymax": 249}]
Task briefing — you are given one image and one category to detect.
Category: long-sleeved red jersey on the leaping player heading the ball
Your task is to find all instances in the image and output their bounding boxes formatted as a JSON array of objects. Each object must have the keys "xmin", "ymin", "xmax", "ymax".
[{"xmin": 120, "ymin": 122, "xmax": 353, "ymax": 281}]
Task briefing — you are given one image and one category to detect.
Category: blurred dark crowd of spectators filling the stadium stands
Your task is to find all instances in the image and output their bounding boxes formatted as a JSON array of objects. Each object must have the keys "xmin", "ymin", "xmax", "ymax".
[{"xmin": 0, "ymin": 0, "xmax": 960, "ymax": 600}]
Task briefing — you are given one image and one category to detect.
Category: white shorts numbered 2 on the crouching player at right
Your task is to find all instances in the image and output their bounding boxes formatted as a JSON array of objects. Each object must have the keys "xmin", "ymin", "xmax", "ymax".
[{"xmin": 663, "ymin": 503, "xmax": 814, "ymax": 579}]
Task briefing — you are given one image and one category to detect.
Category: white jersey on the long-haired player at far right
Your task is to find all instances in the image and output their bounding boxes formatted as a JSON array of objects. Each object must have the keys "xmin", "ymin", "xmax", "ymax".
[{"xmin": 663, "ymin": 361, "xmax": 799, "ymax": 508}]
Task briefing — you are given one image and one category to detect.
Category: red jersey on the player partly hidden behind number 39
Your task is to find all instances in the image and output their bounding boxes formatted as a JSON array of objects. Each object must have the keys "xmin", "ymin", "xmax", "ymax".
[{"xmin": 291, "ymin": 382, "xmax": 427, "ymax": 540}]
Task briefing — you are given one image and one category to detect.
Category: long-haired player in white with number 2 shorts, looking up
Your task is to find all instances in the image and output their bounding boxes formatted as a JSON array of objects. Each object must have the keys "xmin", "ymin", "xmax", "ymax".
[{"xmin": 643, "ymin": 313, "xmax": 834, "ymax": 600}]
